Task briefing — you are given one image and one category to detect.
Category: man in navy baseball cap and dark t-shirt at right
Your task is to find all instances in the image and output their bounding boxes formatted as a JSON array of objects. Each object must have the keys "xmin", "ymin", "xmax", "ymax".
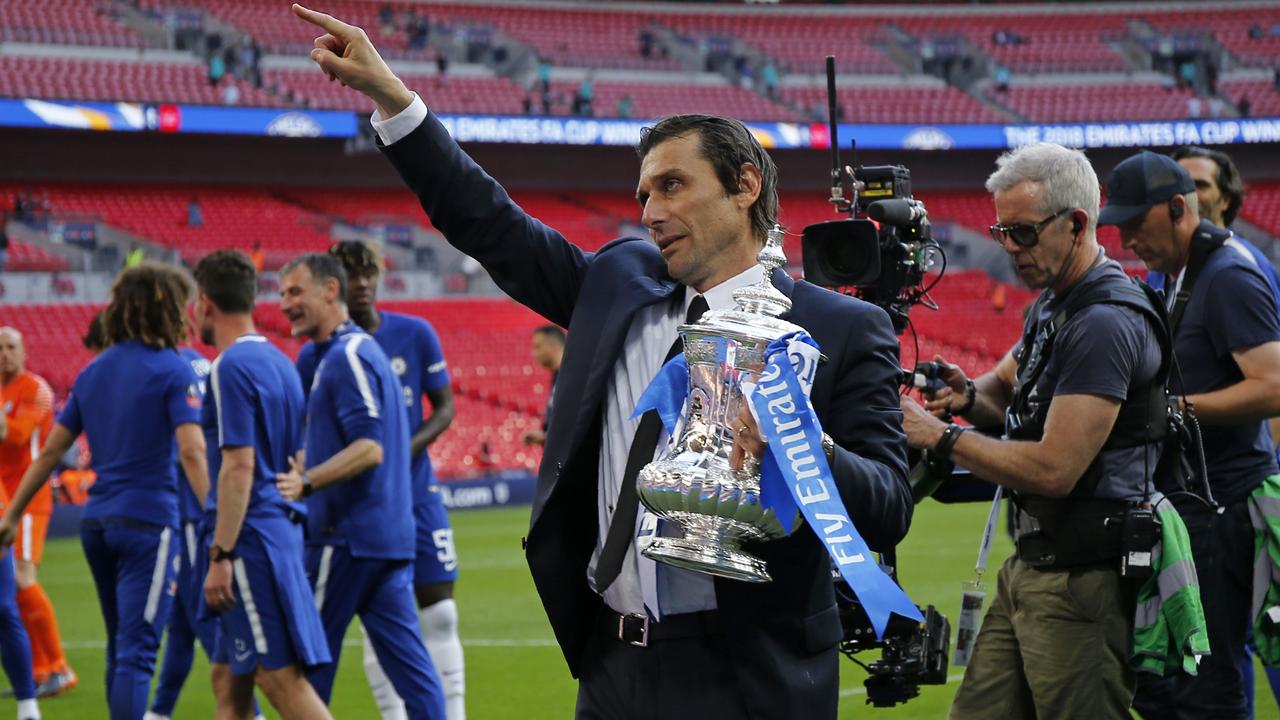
[{"xmin": 1101, "ymin": 152, "xmax": 1280, "ymax": 719}]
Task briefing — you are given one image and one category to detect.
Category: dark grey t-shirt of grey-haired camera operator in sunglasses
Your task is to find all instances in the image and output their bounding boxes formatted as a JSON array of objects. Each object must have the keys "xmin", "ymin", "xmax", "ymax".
[{"xmin": 1013, "ymin": 260, "xmax": 1161, "ymax": 501}]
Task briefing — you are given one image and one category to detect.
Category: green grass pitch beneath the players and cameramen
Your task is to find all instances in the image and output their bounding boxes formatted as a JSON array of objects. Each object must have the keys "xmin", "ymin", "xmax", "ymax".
[{"xmin": 10, "ymin": 501, "xmax": 1280, "ymax": 720}]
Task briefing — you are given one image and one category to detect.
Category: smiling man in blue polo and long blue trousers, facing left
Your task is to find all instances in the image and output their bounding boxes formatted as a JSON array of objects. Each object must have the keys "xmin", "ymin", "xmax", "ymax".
[{"xmin": 276, "ymin": 254, "xmax": 444, "ymax": 719}]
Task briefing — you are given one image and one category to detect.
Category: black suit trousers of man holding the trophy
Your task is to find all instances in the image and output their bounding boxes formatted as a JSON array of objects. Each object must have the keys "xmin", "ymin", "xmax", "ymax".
[{"xmin": 575, "ymin": 611, "xmax": 748, "ymax": 720}]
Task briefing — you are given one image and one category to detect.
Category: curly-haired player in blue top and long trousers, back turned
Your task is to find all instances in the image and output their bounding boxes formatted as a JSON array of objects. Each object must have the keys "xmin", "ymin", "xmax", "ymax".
[{"xmin": 0, "ymin": 263, "xmax": 209, "ymax": 720}]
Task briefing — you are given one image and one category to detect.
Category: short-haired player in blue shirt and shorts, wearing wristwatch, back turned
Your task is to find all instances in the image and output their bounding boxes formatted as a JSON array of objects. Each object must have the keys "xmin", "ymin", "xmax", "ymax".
[{"xmin": 195, "ymin": 250, "xmax": 332, "ymax": 720}]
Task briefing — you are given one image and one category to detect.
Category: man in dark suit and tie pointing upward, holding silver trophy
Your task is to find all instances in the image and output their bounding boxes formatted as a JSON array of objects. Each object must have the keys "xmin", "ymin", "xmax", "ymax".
[{"xmin": 294, "ymin": 5, "xmax": 911, "ymax": 719}]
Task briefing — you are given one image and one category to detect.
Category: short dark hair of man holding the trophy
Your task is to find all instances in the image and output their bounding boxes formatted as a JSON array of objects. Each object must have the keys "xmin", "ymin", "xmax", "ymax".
[{"xmin": 636, "ymin": 115, "xmax": 778, "ymax": 243}]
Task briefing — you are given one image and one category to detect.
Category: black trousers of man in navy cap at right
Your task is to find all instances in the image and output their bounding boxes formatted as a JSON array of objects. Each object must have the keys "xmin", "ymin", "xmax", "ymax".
[{"xmin": 1133, "ymin": 500, "xmax": 1253, "ymax": 720}]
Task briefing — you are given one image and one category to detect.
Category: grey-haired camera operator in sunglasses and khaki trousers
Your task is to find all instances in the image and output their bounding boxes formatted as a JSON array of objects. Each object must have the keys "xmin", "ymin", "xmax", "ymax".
[{"xmin": 902, "ymin": 143, "xmax": 1167, "ymax": 720}]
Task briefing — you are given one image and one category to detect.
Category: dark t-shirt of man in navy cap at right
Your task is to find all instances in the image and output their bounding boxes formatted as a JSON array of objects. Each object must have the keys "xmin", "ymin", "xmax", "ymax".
[{"xmin": 1170, "ymin": 226, "xmax": 1280, "ymax": 503}]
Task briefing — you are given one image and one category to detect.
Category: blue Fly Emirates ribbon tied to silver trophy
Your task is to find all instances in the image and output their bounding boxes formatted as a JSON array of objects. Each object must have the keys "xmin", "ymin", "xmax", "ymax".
[{"xmin": 632, "ymin": 332, "xmax": 923, "ymax": 639}]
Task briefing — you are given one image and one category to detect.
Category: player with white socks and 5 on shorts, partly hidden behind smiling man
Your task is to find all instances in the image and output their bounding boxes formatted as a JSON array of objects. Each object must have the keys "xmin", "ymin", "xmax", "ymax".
[{"xmin": 298, "ymin": 241, "xmax": 466, "ymax": 720}]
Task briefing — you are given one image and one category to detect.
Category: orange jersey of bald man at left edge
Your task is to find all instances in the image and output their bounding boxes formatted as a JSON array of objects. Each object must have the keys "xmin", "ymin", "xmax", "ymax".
[{"xmin": 0, "ymin": 373, "xmax": 54, "ymax": 514}]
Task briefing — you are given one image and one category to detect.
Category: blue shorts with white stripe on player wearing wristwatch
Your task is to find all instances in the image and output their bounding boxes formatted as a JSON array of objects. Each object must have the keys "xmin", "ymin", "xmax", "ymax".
[{"xmin": 204, "ymin": 518, "xmax": 330, "ymax": 675}]
